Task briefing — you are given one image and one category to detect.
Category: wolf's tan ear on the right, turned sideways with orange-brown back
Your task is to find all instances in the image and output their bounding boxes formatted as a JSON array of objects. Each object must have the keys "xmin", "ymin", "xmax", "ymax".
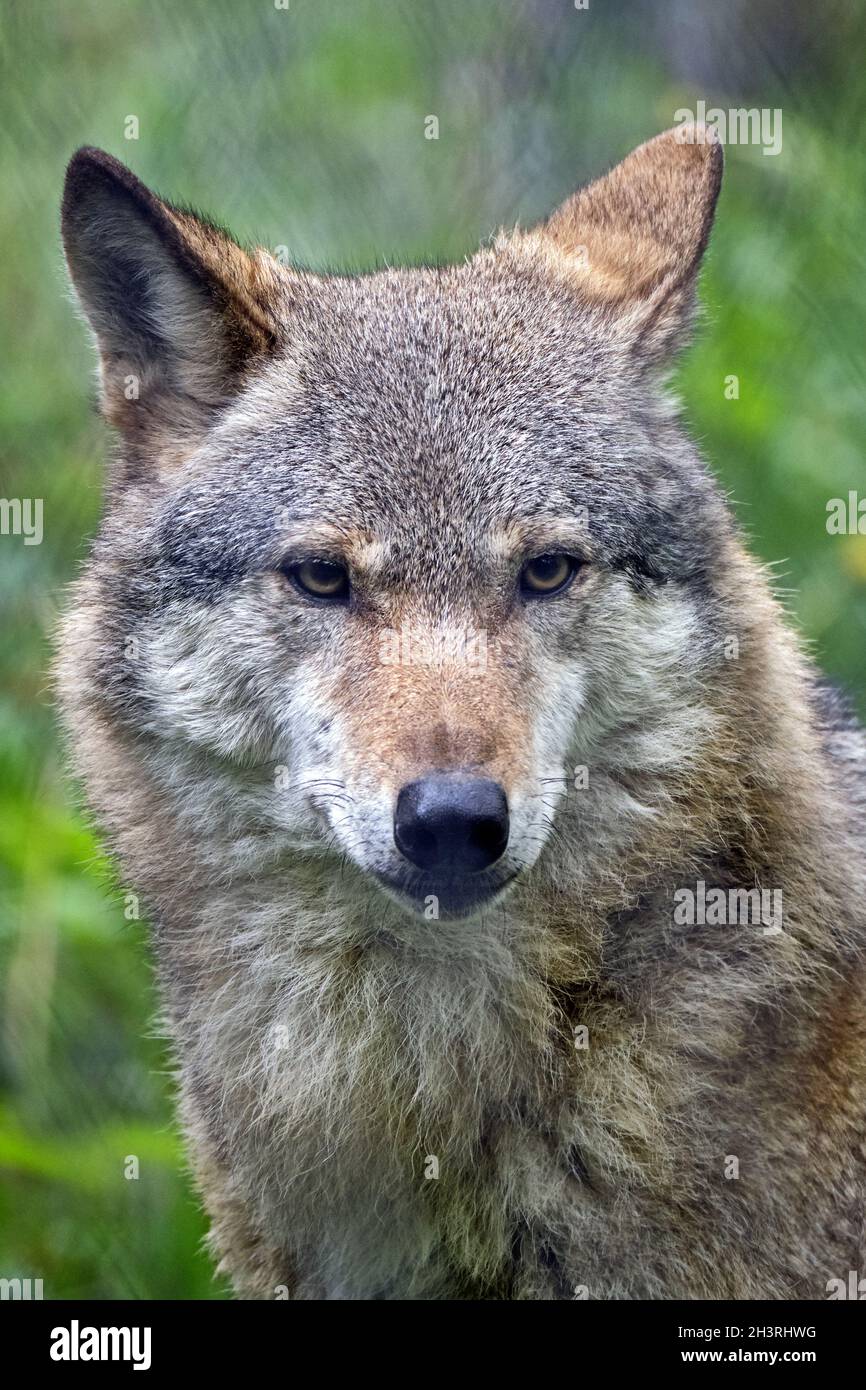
[{"xmin": 525, "ymin": 125, "xmax": 723, "ymax": 363}]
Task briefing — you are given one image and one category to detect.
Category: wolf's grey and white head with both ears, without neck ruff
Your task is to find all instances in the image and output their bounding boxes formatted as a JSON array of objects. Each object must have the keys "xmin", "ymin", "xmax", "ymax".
[{"xmin": 63, "ymin": 128, "xmax": 735, "ymax": 922}]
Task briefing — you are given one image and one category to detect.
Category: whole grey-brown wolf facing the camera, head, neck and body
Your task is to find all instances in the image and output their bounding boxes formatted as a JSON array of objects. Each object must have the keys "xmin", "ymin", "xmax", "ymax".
[{"xmin": 57, "ymin": 126, "xmax": 866, "ymax": 1300}]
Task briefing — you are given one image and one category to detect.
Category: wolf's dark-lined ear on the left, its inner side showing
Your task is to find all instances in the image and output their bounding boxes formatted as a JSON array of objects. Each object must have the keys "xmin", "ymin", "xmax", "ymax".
[{"xmin": 61, "ymin": 149, "xmax": 285, "ymax": 434}]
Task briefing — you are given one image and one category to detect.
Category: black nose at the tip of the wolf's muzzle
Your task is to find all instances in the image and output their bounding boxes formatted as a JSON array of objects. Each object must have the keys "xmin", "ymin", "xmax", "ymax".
[{"xmin": 393, "ymin": 773, "xmax": 509, "ymax": 874}]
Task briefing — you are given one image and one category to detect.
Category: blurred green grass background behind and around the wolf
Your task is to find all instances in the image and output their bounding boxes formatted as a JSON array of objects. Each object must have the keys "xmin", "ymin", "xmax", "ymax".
[{"xmin": 0, "ymin": 0, "xmax": 866, "ymax": 1298}]
